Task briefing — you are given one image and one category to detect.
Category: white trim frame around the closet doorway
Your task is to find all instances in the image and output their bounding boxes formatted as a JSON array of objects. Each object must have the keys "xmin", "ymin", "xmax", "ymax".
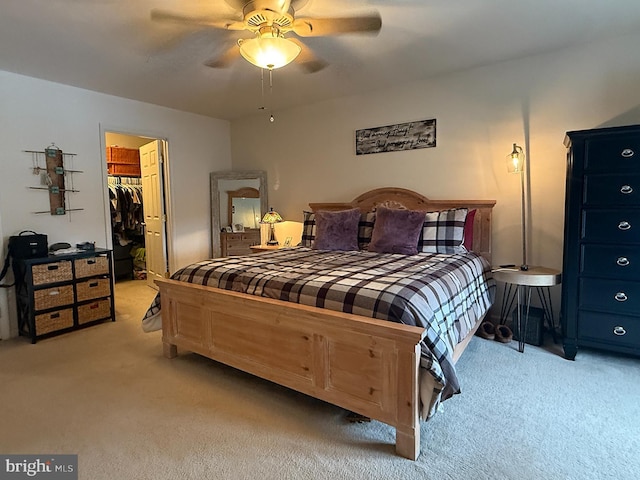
[{"xmin": 100, "ymin": 124, "xmax": 175, "ymax": 273}]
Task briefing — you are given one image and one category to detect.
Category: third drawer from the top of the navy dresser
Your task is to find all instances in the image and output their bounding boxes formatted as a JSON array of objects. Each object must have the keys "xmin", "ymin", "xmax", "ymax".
[{"xmin": 581, "ymin": 208, "xmax": 640, "ymax": 243}]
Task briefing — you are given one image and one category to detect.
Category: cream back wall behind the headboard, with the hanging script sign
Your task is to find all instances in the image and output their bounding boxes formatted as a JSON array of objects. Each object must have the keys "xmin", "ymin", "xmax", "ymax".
[{"xmin": 231, "ymin": 31, "xmax": 640, "ymax": 318}]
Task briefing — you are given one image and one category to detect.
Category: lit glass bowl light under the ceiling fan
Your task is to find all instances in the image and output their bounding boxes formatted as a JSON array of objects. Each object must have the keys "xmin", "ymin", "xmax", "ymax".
[{"xmin": 238, "ymin": 35, "xmax": 301, "ymax": 70}]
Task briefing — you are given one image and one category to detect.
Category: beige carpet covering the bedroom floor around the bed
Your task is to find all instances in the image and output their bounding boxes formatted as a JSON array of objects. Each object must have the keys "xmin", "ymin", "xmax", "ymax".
[{"xmin": 0, "ymin": 281, "xmax": 640, "ymax": 480}]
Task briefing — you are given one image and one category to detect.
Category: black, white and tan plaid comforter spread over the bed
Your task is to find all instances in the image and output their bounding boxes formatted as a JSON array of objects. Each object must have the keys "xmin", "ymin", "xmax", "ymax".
[{"xmin": 143, "ymin": 247, "xmax": 495, "ymax": 412}]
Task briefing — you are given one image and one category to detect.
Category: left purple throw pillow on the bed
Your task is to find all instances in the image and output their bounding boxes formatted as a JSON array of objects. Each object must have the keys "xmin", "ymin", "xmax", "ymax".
[{"xmin": 311, "ymin": 208, "xmax": 360, "ymax": 250}]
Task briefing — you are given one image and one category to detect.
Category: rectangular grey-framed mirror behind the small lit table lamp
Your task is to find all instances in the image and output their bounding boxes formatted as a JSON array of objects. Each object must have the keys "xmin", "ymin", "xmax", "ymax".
[{"xmin": 210, "ymin": 170, "xmax": 268, "ymax": 257}]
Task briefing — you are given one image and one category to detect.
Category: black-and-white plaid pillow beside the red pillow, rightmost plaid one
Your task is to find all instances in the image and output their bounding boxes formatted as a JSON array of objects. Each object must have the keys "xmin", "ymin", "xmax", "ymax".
[{"xmin": 418, "ymin": 208, "xmax": 468, "ymax": 253}]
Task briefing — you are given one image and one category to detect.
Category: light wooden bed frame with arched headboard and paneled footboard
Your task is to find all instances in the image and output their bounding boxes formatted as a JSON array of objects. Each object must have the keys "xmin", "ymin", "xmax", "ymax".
[{"xmin": 156, "ymin": 188, "xmax": 495, "ymax": 460}]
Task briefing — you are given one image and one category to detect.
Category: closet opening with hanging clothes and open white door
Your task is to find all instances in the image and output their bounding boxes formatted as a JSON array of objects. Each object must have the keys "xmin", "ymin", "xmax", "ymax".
[{"xmin": 104, "ymin": 131, "xmax": 169, "ymax": 289}]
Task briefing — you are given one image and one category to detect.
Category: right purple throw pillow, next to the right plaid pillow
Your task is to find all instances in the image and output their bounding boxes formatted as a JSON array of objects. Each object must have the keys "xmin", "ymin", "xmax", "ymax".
[{"xmin": 369, "ymin": 207, "xmax": 425, "ymax": 255}]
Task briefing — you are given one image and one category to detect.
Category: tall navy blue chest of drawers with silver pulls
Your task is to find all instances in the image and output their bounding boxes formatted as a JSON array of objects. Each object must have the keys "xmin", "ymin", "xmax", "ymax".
[{"xmin": 560, "ymin": 125, "xmax": 640, "ymax": 360}]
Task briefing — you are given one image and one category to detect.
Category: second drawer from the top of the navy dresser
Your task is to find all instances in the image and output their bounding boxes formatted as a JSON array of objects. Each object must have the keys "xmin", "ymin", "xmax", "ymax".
[{"xmin": 584, "ymin": 174, "xmax": 640, "ymax": 206}]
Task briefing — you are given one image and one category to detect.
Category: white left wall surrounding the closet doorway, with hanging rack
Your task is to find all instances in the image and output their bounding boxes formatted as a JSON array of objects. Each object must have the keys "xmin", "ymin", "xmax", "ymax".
[{"xmin": 0, "ymin": 71, "xmax": 231, "ymax": 338}]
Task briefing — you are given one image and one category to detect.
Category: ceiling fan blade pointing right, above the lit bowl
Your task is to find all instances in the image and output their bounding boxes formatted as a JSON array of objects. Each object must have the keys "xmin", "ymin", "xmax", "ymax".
[{"xmin": 292, "ymin": 12, "xmax": 382, "ymax": 37}]
